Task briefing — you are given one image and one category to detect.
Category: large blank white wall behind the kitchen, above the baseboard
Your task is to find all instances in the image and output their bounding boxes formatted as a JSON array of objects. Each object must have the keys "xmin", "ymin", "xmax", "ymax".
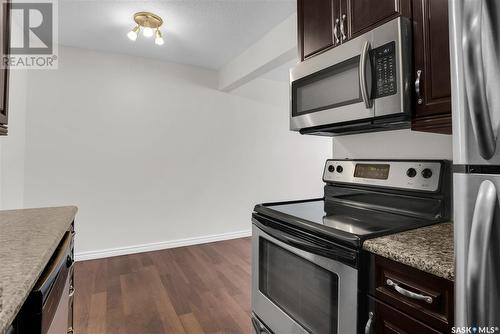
[{"xmin": 20, "ymin": 47, "xmax": 331, "ymax": 255}]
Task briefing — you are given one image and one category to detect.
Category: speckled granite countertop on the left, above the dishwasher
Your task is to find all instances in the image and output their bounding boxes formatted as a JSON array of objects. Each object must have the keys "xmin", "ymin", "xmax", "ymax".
[{"xmin": 0, "ymin": 206, "xmax": 77, "ymax": 334}]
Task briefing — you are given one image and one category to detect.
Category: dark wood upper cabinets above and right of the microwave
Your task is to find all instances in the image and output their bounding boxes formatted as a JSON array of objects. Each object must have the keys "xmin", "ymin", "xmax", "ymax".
[{"xmin": 297, "ymin": 0, "xmax": 451, "ymax": 134}]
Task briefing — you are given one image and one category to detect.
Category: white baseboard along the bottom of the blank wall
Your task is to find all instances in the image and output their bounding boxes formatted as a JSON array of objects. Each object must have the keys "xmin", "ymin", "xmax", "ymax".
[{"xmin": 75, "ymin": 230, "xmax": 252, "ymax": 261}]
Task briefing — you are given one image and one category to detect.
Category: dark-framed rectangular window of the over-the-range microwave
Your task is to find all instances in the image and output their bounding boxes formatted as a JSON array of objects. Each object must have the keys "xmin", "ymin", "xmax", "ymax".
[{"xmin": 292, "ymin": 56, "xmax": 362, "ymax": 116}]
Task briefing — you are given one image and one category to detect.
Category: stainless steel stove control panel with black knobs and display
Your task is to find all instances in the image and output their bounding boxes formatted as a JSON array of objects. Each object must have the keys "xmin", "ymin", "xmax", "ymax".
[{"xmin": 323, "ymin": 160, "xmax": 443, "ymax": 192}]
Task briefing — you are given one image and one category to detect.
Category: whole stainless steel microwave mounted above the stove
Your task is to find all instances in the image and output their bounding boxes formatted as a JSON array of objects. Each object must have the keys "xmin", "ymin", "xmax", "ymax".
[{"xmin": 290, "ymin": 17, "xmax": 412, "ymax": 136}]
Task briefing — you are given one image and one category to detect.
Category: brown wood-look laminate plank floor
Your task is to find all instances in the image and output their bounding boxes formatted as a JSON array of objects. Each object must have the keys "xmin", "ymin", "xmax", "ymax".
[{"xmin": 74, "ymin": 238, "xmax": 251, "ymax": 334}]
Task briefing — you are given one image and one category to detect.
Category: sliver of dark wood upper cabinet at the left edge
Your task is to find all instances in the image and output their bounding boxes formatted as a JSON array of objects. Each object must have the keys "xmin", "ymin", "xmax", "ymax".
[{"xmin": 0, "ymin": 0, "xmax": 10, "ymax": 135}]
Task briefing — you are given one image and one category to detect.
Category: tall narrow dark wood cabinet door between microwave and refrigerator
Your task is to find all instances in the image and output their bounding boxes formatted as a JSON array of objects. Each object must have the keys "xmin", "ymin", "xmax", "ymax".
[{"xmin": 412, "ymin": 0, "xmax": 451, "ymax": 133}]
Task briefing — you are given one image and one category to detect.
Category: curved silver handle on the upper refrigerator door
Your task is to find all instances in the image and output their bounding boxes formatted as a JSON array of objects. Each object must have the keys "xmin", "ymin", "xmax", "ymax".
[{"xmin": 462, "ymin": 0, "xmax": 496, "ymax": 160}]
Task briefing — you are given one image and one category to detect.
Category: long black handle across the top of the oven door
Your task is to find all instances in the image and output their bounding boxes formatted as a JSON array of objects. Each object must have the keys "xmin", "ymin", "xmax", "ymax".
[{"xmin": 258, "ymin": 223, "xmax": 357, "ymax": 264}]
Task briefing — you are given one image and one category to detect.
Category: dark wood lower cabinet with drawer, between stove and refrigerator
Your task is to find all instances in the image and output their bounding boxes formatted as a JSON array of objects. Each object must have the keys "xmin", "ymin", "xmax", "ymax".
[{"xmin": 367, "ymin": 255, "xmax": 454, "ymax": 334}]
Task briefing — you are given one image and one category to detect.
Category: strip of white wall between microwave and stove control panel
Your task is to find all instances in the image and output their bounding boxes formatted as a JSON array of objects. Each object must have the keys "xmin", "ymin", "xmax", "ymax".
[{"xmin": 333, "ymin": 130, "xmax": 453, "ymax": 160}]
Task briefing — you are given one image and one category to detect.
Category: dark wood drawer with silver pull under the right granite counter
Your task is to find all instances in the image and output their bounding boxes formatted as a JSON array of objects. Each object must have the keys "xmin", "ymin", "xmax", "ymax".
[{"xmin": 375, "ymin": 256, "xmax": 453, "ymax": 332}]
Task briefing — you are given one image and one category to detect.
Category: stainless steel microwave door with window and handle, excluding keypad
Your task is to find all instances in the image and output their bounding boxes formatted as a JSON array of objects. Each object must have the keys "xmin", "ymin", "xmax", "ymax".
[{"xmin": 290, "ymin": 34, "xmax": 374, "ymax": 130}]
